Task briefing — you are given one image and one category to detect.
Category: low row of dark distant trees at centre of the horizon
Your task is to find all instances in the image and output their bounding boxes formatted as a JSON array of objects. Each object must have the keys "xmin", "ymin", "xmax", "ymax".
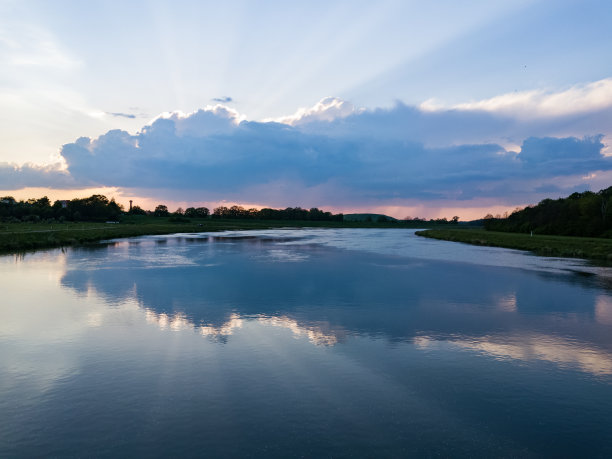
[{"xmin": 212, "ymin": 206, "xmax": 343, "ymax": 221}]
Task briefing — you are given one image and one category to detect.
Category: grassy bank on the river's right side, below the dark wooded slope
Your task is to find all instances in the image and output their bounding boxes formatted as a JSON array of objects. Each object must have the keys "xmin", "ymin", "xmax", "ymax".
[{"xmin": 416, "ymin": 229, "xmax": 612, "ymax": 262}]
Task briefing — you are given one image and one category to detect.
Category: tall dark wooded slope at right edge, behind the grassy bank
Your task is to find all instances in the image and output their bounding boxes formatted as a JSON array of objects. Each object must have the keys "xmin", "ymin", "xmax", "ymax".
[{"xmin": 484, "ymin": 187, "xmax": 612, "ymax": 237}]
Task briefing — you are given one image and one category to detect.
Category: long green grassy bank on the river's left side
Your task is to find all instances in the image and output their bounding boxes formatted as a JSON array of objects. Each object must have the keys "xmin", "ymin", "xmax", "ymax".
[{"xmin": 0, "ymin": 216, "xmax": 440, "ymax": 253}]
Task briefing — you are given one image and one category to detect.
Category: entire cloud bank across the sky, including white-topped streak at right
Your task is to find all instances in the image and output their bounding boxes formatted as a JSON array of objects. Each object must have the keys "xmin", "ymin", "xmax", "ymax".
[{"xmin": 0, "ymin": 79, "xmax": 612, "ymax": 211}]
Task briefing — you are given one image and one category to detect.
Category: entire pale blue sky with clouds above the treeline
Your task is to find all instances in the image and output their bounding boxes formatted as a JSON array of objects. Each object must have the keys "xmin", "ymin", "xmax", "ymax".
[{"xmin": 0, "ymin": 0, "xmax": 612, "ymax": 220}]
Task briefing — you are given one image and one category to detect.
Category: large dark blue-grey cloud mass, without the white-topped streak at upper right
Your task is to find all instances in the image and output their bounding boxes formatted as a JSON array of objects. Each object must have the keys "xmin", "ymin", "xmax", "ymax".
[{"xmin": 55, "ymin": 106, "xmax": 612, "ymax": 204}]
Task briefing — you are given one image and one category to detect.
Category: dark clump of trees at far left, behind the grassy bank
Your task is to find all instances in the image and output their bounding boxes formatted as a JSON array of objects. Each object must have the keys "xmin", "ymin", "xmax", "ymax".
[{"xmin": 0, "ymin": 194, "xmax": 123, "ymax": 223}]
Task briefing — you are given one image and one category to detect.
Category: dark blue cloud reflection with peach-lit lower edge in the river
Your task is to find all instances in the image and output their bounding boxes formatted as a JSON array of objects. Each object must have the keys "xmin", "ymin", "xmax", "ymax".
[{"xmin": 52, "ymin": 230, "xmax": 612, "ymax": 375}]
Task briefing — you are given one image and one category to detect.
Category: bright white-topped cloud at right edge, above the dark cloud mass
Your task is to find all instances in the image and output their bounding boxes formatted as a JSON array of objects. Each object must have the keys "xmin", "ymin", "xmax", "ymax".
[{"xmin": 407, "ymin": 78, "xmax": 612, "ymax": 146}]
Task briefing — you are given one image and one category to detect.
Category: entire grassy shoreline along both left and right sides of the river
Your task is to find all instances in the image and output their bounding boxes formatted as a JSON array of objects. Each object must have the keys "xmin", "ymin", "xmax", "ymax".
[{"xmin": 7, "ymin": 219, "xmax": 612, "ymax": 265}]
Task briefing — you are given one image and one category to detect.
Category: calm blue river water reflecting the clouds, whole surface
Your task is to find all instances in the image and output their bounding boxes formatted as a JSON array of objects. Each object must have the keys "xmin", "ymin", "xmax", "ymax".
[{"xmin": 0, "ymin": 230, "xmax": 612, "ymax": 457}]
